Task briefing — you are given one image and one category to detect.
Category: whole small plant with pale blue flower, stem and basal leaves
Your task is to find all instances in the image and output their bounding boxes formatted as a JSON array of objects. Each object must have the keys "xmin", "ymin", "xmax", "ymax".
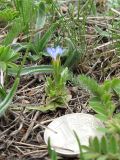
[{"xmin": 46, "ymin": 46, "xmax": 69, "ymax": 109}]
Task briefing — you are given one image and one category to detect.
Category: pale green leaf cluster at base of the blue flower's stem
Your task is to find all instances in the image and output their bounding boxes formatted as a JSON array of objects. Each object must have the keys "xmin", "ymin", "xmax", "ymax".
[{"xmin": 46, "ymin": 68, "xmax": 68, "ymax": 106}]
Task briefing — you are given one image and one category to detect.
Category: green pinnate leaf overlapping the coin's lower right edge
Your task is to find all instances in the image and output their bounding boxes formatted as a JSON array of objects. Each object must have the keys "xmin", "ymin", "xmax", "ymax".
[{"xmin": 83, "ymin": 135, "xmax": 120, "ymax": 160}]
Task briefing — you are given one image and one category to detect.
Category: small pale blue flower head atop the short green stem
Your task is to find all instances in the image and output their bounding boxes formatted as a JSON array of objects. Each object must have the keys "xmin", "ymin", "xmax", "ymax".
[{"xmin": 47, "ymin": 46, "xmax": 64, "ymax": 60}]
